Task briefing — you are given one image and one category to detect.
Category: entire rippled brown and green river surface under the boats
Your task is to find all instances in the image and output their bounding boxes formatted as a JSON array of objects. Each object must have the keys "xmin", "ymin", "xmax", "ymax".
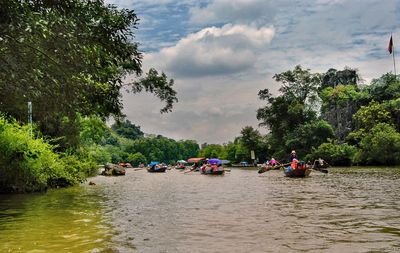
[{"xmin": 0, "ymin": 167, "xmax": 400, "ymax": 253}]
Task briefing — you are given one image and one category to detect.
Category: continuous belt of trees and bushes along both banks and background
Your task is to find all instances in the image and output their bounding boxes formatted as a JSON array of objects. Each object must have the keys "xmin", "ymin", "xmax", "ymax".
[{"xmin": 0, "ymin": 0, "xmax": 400, "ymax": 192}]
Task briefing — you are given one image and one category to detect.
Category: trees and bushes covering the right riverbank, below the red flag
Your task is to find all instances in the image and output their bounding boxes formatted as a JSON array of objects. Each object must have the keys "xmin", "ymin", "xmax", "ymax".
[{"xmin": 201, "ymin": 66, "xmax": 400, "ymax": 165}]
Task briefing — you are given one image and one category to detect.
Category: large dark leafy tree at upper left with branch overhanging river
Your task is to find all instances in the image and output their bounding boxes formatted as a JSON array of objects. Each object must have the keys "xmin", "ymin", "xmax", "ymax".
[{"xmin": 0, "ymin": 0, "xmax": 177, "ymax": 145}]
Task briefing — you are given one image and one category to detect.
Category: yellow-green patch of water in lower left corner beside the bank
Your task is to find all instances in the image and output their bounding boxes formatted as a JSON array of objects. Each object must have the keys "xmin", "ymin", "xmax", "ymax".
[{"xmin": 0, "ymin": 187, "xmax": 113, "ymax": 252}]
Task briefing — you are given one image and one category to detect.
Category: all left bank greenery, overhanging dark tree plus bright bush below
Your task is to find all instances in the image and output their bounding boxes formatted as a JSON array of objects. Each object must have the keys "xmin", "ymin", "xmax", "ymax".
[{"xmin": 0, "ymin": 0, "xmax": 177, "ymax": 192}]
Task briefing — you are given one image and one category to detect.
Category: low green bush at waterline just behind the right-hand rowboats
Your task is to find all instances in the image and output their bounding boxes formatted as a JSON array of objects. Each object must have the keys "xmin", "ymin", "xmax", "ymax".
[{"xmin": 306, "ymin": 142, "xmax": 357, "ymax": 166}]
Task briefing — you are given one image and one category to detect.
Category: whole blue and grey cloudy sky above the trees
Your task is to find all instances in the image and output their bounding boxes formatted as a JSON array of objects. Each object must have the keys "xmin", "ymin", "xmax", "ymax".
[{"xmin": 106, "ymin": 0, "xmax": 400, "ymax": 144}]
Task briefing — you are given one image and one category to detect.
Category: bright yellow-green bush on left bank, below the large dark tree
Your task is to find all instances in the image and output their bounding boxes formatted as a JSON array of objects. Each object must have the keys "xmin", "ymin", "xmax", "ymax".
[{"xmin": 0, "ymin": 116, "xmax": 95, "ymax": 192}]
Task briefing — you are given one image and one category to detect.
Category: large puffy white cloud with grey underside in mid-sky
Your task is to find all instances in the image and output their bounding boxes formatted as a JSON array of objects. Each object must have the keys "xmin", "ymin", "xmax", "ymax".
[{"xmin": 146, "ymin": 24, "xmax": 275, "ymax": 77}]
